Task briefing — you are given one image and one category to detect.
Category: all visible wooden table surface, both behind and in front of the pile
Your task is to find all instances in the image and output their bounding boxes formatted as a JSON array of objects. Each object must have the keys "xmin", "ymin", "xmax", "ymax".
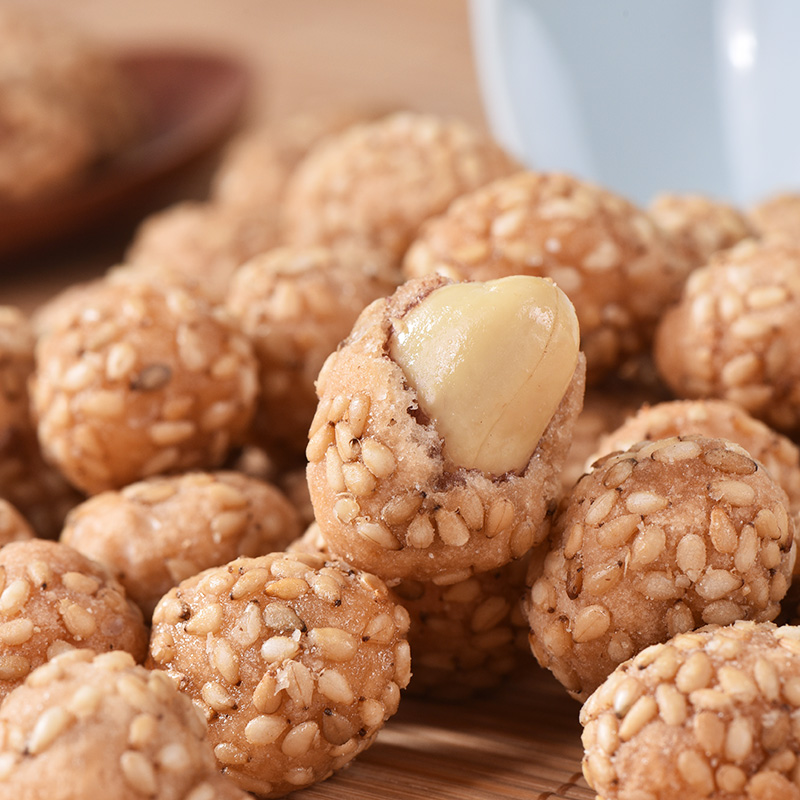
[{"xmin": 0, "ymin": 0, "xmax": 594, "ymax": 800}]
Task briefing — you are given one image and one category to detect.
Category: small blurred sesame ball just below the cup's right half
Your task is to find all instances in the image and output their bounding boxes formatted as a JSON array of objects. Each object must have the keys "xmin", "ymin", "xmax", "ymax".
[{"xmin": 647, "ymin": 194, "xmax": 755, "ymax": 269}]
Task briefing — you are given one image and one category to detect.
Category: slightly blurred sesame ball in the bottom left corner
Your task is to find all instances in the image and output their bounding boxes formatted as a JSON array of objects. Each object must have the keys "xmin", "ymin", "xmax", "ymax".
[{"xmin": 0, "ymin": 650, "xmax": 250, "ymax": 800}]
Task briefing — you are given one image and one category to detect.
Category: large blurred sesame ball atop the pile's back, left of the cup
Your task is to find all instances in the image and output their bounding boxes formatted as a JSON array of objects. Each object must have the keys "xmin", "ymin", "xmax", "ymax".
[{"xmin": 283, "ymin": 112, "xmax": 518, "ymax": 259}]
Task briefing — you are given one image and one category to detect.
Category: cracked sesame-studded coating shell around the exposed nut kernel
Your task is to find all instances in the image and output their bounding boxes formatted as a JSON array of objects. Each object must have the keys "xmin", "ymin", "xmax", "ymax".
[{"xmin": 306, "ymin": 276, "xmax": 584, "ymax": 583}]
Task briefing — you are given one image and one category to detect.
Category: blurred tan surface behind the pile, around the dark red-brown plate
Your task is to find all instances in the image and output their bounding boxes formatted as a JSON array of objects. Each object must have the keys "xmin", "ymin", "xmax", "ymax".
[{"xmin": 6, "ymin": 0, "xmax": 486, "ymax": 307}]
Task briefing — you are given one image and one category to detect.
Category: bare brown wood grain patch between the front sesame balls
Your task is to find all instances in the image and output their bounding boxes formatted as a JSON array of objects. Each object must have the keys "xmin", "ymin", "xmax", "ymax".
[{"xmin": 290, "ymin": 661, "xmax": 595, "ymax": 800}]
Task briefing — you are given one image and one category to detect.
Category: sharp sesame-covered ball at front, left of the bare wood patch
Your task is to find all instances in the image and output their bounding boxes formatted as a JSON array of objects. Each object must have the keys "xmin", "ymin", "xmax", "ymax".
[{"xmin": 149, "ymin": 553, "xmax": 411, "ymax": 797}]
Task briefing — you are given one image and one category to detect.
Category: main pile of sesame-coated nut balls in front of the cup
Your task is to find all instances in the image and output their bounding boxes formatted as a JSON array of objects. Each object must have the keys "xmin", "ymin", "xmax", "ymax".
[{"xmin": 7, "ymin": 12, "xmax": 800, "ymax": 800}]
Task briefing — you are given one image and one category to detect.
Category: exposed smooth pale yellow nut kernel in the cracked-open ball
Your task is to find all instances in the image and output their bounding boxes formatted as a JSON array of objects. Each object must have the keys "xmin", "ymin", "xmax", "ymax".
[{"xmin": 390, "ymin": 275, "xmax": 579, "ymax": 475}]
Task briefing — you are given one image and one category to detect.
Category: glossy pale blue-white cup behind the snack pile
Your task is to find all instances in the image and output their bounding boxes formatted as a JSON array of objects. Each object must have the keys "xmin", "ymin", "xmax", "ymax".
[{"xmin": 470, "ymin": 0, "xmax": 800, "ymax": 206}]
